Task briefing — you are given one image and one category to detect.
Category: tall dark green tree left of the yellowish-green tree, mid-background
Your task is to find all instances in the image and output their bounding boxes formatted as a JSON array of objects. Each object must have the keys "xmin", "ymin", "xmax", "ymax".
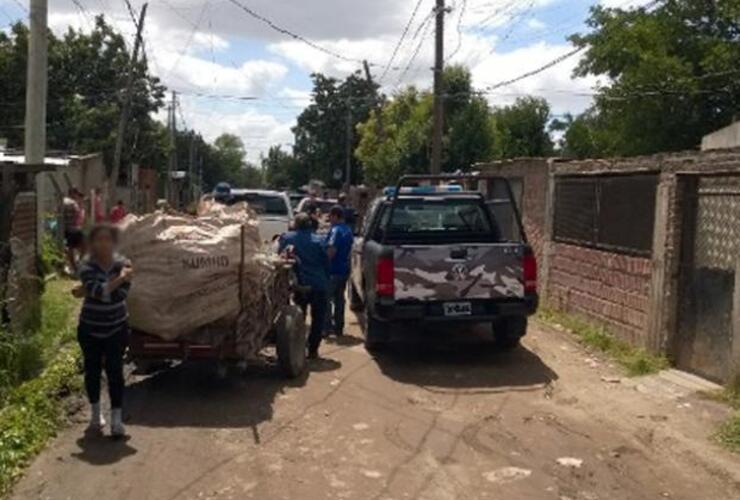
[{"xmin": 293, "ymin": 72, "xmax": 382, "ymax": 187}]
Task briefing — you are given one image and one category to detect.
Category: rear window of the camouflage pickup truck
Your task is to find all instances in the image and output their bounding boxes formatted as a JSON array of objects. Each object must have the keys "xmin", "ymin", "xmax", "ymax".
[{"xmin": 378, "ymin": 198, "xmax": 498, "ymax": 241}]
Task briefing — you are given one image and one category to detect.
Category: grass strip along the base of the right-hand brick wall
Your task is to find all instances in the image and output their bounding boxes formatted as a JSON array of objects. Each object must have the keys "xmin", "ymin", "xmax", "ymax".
[{"xmin": 537, "ymin": 309, "xmax": 670, "ymax": 376}]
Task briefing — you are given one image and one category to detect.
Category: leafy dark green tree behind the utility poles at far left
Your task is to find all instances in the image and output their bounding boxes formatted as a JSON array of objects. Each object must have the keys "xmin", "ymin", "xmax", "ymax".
[{"xmin": 0, "ymin": 16, "xmax": 164, "ymax": 170}]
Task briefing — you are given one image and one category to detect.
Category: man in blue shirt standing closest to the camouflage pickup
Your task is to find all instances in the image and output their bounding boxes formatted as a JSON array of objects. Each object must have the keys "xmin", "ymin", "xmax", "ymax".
[{"xmin": 326, "ymin": 205, "xmax": 354, "ymax": 336}]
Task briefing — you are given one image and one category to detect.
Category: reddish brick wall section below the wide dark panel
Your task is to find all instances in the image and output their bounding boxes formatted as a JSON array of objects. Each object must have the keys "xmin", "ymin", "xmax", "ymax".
[{"xmin": 548, "ymin": 243, "xmax": 651, "ymax": 345}]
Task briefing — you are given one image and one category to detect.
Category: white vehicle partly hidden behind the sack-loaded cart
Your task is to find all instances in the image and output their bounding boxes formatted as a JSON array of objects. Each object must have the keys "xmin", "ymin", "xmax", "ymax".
[{"xmin": 227, "ymin": 189, "xmax": 293, "ymax": 241}]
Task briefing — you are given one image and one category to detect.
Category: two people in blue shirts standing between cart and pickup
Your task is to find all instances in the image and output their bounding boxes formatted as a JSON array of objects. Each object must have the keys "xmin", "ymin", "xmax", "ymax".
[{"xmin": 278, "ymin": 199, "xmax": 354, "ymax": 359}]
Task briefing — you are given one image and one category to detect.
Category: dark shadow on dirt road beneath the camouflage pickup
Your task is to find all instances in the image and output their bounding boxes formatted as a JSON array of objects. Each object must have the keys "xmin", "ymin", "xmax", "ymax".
[{"xmin": 374, "ymin": 325, "xmax": 558, "ymax": 392}]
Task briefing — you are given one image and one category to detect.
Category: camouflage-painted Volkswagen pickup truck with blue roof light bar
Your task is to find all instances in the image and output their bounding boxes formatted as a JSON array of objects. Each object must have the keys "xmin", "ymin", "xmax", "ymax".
[{"xmin": 350, "ymin": 175, "xmax": 538, "ymax": 350}]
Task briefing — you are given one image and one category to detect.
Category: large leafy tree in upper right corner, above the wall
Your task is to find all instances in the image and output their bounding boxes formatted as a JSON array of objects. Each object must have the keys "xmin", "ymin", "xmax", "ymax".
[{"xmin": 571, "ymin": 0, "xmax": 740, "ymax": 155}]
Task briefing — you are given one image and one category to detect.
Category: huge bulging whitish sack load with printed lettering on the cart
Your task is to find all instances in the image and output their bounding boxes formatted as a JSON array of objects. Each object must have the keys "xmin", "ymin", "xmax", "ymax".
[{"xmin": 121, "ymin": 203, "xmax": 289, "ymax": 358}]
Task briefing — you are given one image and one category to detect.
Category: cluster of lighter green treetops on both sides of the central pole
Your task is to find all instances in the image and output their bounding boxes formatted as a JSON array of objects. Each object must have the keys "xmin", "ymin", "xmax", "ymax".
[{"xmin": 355, "ymin": 66, "xmax": 552, "ymax": 184}]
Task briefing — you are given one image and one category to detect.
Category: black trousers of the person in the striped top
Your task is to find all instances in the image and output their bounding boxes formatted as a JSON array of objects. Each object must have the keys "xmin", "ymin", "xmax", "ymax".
[{"xmin": 77, "ymin": 324, "xmax": 128, "ymax": 408}]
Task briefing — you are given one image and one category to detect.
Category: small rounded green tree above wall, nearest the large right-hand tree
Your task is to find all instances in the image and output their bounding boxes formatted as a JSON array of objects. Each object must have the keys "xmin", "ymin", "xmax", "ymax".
[{"xmin": 493, "ymin": 97, "xmax": 553, "ymax": 158}]
